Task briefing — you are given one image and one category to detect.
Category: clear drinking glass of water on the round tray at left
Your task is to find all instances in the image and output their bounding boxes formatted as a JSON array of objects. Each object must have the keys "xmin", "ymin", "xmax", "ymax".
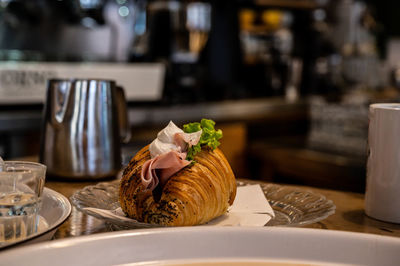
[{"xmin": 0, "ymin": 161, "xmax": 46, "ymax": 246}]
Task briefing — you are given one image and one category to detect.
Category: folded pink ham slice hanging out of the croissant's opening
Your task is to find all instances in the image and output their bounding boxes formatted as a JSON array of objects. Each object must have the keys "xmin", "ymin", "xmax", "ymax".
[{"xmin": 141, "ymin": 151, "xmax": 190, "ymax": 191}]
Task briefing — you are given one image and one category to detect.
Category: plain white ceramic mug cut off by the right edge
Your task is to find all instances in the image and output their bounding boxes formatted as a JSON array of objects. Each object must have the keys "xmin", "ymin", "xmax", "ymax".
[{"xmin": 365, "ymin": 103, "xmax": 400, "ymax": 223}]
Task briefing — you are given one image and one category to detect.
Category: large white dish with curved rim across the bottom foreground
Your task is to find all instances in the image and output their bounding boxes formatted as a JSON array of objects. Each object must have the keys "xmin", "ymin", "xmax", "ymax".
[{"xmin": 0, "ymin": 226, "xmax": 400, "ymax": 266}]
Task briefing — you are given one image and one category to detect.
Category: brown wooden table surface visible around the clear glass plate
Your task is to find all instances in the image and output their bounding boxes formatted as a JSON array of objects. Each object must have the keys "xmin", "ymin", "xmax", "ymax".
[{"xmin": 46, "ymin": 181, "xmax": 400, "ymax": 239}]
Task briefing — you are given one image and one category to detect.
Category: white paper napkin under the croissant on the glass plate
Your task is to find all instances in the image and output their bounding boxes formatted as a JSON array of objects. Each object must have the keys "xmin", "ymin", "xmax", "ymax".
[{"xmin": 83, "ymin": 185, "xmax": 275, "ymax": 226}]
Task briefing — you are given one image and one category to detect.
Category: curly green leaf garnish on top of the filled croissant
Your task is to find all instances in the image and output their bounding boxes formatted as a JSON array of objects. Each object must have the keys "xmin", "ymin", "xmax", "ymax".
[{"xmin": 183, "ymin": 118, "xmax": 222, "ymax": 161}]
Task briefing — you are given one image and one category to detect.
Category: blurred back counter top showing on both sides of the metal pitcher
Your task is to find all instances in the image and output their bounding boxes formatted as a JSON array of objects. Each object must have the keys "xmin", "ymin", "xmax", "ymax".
[{"xmin": 0, "ymin": 97, "xmax": 307, "ymax": 132}]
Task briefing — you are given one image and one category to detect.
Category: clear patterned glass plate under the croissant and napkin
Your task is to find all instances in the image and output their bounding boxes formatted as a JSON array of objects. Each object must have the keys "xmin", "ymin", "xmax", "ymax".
[{"xmin": 71, "ymin": 180, "xmax": 336, "ymax": 230}]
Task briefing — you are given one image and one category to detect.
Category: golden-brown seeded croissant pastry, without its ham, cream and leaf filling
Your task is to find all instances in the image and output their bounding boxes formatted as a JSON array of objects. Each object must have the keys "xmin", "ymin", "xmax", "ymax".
[{"xmin": 119, "ymin": 146, "xmax": 236, "ymax": 226}]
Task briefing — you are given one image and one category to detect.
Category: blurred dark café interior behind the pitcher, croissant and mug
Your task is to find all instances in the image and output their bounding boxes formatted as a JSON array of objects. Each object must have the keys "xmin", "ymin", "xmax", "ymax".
[{"xmin": 0, "ymin": 0, "xmax": 400, "ymax": 192}]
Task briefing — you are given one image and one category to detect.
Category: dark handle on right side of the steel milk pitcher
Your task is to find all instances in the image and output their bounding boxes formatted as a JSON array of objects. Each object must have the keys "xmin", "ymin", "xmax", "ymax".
[{"xmin": 116, "ymin": 86, "xmax": 131, "ymax": 143}]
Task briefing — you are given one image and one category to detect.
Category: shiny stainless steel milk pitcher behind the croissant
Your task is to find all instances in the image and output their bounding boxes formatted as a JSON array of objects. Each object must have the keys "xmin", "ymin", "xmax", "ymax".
[{"xmin": 40, "ymin": 79, "xmax": 130, "ymax": 179}]
